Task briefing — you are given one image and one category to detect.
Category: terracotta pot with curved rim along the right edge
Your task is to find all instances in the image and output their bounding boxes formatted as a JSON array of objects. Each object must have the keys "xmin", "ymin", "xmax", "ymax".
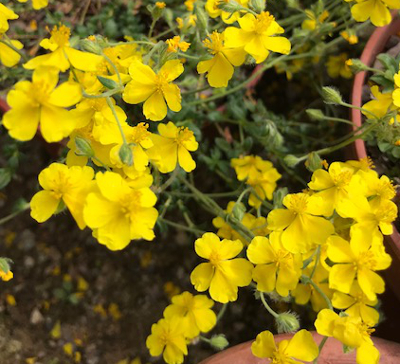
[{"xmin": 351, "ymin": 17, "xmax": 400, "ymax": 302}]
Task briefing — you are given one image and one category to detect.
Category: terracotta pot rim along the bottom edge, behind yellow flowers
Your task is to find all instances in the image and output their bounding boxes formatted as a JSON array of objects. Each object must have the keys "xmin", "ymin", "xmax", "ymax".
[{"xmin": 199, "ymin": 332, "xmax": 400, "ymax": 364}]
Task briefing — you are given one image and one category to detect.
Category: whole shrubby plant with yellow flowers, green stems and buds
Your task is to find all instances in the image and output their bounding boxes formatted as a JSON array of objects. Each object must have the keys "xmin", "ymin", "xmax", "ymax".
[{"xmin": 0, "ymin": 0, "xmax": 400, "ymax": 364}]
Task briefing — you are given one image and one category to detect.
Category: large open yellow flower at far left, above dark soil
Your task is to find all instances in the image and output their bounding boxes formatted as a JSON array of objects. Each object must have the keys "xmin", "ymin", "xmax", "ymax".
[{"xmin": 3, "ymin": 67, "xmax": 82, "ymax": 143}]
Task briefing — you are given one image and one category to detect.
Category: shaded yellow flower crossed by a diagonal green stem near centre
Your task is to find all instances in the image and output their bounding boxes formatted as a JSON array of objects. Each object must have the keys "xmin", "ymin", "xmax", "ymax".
[{"xmin": 212, "ymin": 201, "xmax": 269, "ymax": 245}]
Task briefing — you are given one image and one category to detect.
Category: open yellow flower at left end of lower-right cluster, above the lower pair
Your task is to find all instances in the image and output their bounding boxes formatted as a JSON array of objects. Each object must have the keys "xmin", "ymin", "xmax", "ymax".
[{"xmin": 190, "ymin": 233, "xmax": 253, "ymax": 303}]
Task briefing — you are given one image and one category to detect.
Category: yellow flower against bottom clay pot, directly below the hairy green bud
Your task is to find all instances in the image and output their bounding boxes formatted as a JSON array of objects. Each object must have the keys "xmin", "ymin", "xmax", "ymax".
[{"xmin": 251, "ymin": 330, "xmax": 319, "ymax": 364}]
